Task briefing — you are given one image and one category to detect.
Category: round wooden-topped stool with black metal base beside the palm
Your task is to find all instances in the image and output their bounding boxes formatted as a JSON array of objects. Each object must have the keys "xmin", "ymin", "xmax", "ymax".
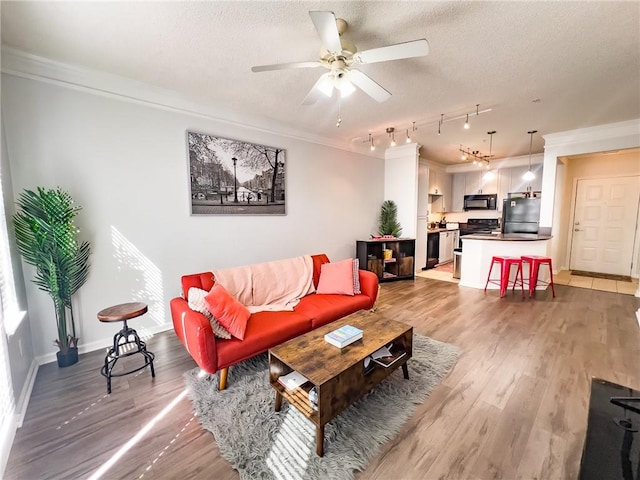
[{"xmin": 98, "ymin": 302, "xmax": 156, "ymax": 393}]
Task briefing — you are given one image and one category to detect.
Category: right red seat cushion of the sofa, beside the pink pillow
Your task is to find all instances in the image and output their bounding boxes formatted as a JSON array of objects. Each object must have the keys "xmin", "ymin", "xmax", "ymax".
[{"xmin": 294, "ymin": 294, "xmax": 371, "ymax": 328}]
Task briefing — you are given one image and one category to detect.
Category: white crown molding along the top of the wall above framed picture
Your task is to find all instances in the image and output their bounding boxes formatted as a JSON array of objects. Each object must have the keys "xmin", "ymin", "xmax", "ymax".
[{"xmin": 0, "ymin": 45, "xmax": 374, "ymax": 156}]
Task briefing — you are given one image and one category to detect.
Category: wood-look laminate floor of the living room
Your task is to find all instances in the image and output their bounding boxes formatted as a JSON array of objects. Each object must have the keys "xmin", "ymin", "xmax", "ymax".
[{"xmin": 5, "ymin": 278, "xmax": 640, "ymax": 480}]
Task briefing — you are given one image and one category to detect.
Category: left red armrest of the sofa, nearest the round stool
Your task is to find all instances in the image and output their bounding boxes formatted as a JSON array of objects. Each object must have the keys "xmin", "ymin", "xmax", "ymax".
[{"xmin": 170, "ymin": 297, "xmax": 218, "ymax": 373}]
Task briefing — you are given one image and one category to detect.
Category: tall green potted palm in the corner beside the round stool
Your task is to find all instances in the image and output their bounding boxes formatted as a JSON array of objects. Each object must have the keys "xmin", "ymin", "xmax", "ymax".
[{"xmin": 13, "ymin": 187, "xmax": 91, "ymax": 367}]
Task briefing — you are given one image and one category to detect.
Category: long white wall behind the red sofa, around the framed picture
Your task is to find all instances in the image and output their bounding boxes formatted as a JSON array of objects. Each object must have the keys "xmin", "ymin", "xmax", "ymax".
[{"xmin": 2, "ymin": 74, "xmax": 384, "ymax": 361}]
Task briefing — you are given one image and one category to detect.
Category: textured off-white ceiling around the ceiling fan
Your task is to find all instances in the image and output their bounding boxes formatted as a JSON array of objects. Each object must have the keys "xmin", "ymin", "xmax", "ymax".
[{"xmin": 1, "ymin": 1, "xmax": 640, "ymax": 164}]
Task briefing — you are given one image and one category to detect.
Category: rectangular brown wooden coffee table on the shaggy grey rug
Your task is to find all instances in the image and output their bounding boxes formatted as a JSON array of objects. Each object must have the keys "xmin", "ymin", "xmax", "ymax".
[{"xmin": 269, "ymin": 312, "xmax": 413, "ymax": 456}]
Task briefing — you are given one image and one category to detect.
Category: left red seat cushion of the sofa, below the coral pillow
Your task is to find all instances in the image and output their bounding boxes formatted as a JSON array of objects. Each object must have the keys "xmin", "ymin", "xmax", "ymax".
[{"xmin": 216, "ymin": 312, "xmax": 311, "ymax": 368}]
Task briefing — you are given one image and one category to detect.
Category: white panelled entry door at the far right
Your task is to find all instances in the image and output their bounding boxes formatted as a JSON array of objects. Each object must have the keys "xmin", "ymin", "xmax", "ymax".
[{"xmin": 569, "ymin": 176, "xmax": 640, "ymax": 276}]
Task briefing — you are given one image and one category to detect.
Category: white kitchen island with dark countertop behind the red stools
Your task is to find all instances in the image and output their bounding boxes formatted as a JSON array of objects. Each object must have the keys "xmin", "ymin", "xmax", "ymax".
[{"xmin": 459, "ymin": 233, "xmax": 551, "ymax": 289}]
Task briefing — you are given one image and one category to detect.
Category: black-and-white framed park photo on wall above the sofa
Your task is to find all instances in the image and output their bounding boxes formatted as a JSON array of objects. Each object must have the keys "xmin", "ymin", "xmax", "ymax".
[{"xmin": 187, "ymin": 131, "xmax": 286, "ymax": 215}]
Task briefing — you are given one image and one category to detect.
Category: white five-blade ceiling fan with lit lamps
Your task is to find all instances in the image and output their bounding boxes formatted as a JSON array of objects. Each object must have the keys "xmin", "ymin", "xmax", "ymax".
[{"xmin": 251, "ymin": 10, "xmax": 429, "ymax": 105}]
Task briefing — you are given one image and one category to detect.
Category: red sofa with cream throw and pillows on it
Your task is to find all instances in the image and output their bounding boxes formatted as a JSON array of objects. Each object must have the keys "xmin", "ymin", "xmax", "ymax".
[{"xmin": 171, "ymin": 254, "xmax": 378, "ymax": 390}]
